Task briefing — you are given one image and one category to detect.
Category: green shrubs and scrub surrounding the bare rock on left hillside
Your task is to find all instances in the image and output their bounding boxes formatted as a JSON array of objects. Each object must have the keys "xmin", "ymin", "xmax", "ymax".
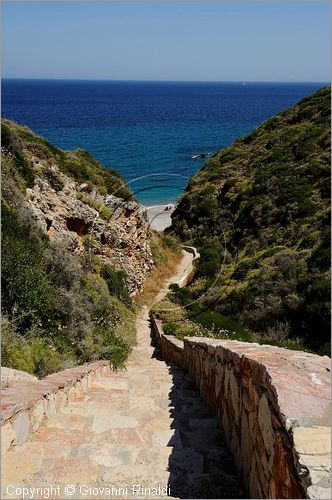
[{"xmin": 1, "ymin": 121, "xmax": 135, "ymax": 376}]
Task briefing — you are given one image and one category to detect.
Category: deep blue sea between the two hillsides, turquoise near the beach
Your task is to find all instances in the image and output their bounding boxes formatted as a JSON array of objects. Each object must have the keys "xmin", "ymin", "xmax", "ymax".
[{"xmin": 2, "ymin": 80, "xmax": 324, "ymax": 205}]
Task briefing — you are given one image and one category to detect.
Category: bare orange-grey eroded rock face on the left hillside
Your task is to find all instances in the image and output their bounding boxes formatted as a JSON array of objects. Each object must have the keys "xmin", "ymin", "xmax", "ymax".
[{"xmin": 26, "ymin": 158, "xmax": 153, "ymax": 294}]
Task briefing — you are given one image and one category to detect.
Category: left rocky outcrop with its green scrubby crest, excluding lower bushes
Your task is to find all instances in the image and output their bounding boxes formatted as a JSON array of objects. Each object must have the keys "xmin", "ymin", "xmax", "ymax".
[{"xmin": 2, "ymin": 120, "xmax": 153, "ymax": 295}]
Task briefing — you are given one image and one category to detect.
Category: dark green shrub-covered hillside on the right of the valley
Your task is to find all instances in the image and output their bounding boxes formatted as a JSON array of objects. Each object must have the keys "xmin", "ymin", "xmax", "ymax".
[{"xmin": 172, "ymin": 88, "xmax": 331, "ymax": 351}]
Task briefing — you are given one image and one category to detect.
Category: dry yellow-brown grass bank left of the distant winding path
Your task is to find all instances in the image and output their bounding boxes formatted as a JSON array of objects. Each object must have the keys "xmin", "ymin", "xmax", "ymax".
[{"xmin": 136, "ymin": 232, "xmax": 181, "ymax": 307}]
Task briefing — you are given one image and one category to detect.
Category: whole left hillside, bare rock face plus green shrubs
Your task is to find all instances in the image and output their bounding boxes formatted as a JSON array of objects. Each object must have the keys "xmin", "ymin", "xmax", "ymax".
[{"xmin": 1, "ymin": 120, "xmax": 153, "ymax": 375}]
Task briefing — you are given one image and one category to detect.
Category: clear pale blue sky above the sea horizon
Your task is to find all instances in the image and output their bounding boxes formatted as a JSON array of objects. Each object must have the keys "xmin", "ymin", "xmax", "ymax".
[{"xmin": 2, "ymin": 1, "xmax": 330, "ymax": 81}]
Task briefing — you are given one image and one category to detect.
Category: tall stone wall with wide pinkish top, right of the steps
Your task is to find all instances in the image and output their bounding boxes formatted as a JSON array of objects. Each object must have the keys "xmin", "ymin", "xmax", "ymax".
[{"xmin": 152, "ymin": 318, "xmax": 331, "ymax": 498}]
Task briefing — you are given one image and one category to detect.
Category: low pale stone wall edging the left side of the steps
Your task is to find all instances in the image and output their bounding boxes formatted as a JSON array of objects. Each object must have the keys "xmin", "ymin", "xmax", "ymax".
[{"xmin": 1, "ymin": 361, "xmax": 111, "ymax": 454}]
